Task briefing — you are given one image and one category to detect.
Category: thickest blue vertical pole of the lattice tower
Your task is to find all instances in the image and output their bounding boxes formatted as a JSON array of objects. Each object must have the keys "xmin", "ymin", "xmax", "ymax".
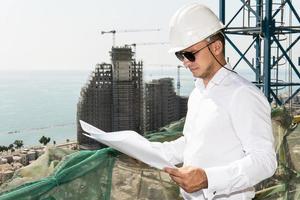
[{"xmin": 263, "ymin": 0, "xmax": 274, "ymax": 102}]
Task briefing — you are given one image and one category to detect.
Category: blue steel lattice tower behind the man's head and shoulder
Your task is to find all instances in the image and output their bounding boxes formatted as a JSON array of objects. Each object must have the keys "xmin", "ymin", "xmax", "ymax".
[{"xmin": 219, "ymin": 0, "xmax": 300, "ymax": 111}]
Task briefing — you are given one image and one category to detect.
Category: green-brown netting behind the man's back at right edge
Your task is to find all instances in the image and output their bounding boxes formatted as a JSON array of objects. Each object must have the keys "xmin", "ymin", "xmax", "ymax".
[{"xmin": 255, "ymin": 107, "xmax": 300, "ymax": 200}]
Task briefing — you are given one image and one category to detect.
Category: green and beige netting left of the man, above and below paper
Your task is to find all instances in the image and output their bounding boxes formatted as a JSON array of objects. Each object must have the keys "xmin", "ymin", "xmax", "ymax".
[{"xmin": 0, "ymin": 120, "xmax": 184, "ymax": 200}]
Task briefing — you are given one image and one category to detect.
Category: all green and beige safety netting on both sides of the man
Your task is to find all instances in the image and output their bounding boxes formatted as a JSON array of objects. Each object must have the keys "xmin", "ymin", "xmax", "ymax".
[{"xmin": 0, "ymin": 108, "xmax": 300, "ymax": 200}]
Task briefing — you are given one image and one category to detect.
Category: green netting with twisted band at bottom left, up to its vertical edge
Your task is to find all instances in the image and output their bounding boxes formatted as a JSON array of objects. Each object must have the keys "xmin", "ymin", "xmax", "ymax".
[{"xmin": 0, "ymin": 148, "xmax": 115, "ymax": 200}]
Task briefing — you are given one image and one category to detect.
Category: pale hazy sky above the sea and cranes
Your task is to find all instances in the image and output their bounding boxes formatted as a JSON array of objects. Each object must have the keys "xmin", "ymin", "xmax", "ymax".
[{"xmin": 0, "ymin": 0, "xmax": 300, "ymax": 70}]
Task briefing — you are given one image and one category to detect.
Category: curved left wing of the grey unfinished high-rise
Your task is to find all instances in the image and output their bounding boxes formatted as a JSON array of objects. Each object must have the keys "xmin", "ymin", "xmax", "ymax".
[{"xmin": 77, "ymin": 63, "xmax": 112, "ymax": 149}]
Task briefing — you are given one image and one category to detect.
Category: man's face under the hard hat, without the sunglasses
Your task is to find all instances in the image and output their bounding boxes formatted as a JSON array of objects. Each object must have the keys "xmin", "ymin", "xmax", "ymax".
[{"xmin": 183, "ymin": 40, "xmax": 213, "ymax": 79}]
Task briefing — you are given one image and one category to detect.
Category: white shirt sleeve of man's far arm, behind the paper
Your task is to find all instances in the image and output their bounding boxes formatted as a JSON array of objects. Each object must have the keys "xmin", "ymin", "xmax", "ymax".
[{"xmin": 151, "ymin": 136, "xmax": 185, "ymax": 165}]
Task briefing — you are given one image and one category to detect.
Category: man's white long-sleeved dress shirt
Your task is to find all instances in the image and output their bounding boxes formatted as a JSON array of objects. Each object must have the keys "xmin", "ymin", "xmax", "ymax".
[{"xmin": 153, "ymin": 65, "xmax": 277, "ymax": 200}]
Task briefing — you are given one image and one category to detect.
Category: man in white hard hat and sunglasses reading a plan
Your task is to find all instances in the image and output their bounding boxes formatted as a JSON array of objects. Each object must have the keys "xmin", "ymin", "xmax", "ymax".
[{"xmin": 153, "ymin": 3, "xmax": 277, "ymax": 200}]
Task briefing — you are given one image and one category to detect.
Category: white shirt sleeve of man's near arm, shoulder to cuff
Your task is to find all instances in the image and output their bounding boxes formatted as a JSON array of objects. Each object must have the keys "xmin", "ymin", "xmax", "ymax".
[{"xmin": 204, "ymin": 86, "xmax": 277, "ymax": 199}]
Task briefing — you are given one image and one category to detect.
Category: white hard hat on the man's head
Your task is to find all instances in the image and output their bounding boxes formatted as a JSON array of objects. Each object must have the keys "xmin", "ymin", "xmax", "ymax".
[{"xmin": 169, "ymin": 3, "xmax": 224, "ymax": 52}]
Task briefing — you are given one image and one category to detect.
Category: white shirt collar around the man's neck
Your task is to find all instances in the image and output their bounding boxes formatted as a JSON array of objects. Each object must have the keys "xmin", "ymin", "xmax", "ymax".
[{"xmin": 195, "ymin": 64, "xmax": 231, "ymax": 90}]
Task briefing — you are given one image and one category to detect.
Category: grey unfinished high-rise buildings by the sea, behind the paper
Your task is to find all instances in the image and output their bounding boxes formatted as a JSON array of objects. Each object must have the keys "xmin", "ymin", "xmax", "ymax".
[{"xmin": 77, "ymin": 46, "xmax": 187, "ymax": 149}]
